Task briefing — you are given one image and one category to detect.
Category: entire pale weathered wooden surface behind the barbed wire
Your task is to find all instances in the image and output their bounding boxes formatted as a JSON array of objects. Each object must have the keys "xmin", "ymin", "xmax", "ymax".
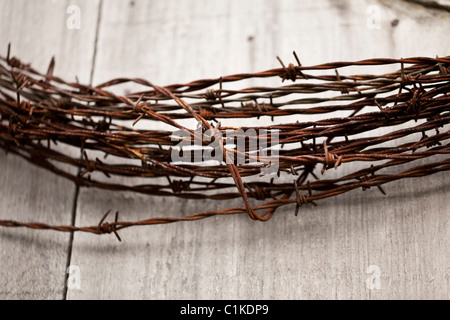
[{"xmin": 0, "ymin": 0, "xmax": 450, "ymax": 299}]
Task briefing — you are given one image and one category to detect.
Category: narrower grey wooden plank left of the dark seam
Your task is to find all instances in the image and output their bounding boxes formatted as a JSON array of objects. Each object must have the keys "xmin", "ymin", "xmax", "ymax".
[{"xmin": 0, "ymin": 0, "xmax": 98, "ymax": 299}]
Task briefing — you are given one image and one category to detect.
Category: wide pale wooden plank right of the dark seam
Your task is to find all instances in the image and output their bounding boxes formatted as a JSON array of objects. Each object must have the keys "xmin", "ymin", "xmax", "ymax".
[{"xmin": 61, "ymin": 0, "xmax": 450, "ymax": 299}]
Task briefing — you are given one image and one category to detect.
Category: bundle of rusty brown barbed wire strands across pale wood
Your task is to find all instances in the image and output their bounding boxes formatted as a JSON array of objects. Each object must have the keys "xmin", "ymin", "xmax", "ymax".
[{"xmin": 0, "ymin": 45, "xmax": 450, "ymax": 240}]
